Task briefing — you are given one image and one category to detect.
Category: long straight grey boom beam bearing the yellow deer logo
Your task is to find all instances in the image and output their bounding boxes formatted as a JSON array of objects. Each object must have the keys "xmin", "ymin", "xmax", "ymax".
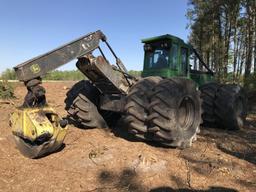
[{"xmin": 14, "ymin": 30, "xmax": 106, "ymax": 82}]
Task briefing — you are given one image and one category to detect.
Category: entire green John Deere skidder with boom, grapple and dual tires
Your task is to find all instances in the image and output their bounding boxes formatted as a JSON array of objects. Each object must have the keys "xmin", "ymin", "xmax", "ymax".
[{"xmin": 10, "ymin": 31, "xmax": 246, "ymax": 158}]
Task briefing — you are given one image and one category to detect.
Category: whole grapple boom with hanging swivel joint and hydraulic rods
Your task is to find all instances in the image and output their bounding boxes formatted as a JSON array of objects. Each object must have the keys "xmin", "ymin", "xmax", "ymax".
[{"xmin": 14, "ymin": 30, "xmax": 134, "ymax": 107}]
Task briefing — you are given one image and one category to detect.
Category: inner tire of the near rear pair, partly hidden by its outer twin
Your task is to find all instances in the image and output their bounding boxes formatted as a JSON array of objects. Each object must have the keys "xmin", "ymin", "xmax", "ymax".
[{"xmin": 124, "ymin": 76, "xmax": 161, "ymax": 139}]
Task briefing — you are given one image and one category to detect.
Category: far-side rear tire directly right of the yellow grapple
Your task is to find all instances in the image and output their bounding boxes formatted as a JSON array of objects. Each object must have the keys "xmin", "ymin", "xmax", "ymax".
[{"xmin": 65, "ymin": 80, "xmax": 111, "ymax": 128}]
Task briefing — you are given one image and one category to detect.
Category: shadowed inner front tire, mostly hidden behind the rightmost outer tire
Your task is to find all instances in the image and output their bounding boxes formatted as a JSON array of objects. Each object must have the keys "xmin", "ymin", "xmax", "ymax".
[{"xmin": 199, "ymin": 82, "xmax": 220, "ymax": 127}]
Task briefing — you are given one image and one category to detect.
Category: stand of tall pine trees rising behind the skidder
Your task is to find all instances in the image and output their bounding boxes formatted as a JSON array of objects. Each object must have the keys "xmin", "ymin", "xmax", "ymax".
[{"xmin": 187, "ymin": 0, "xmax": 256, "ymax": 85}]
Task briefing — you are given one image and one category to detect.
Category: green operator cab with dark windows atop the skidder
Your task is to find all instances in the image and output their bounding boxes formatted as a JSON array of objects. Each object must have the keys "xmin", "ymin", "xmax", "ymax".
[{"xmin": 142, "ymin": 34, "xmax": 214, "ymax": 86}]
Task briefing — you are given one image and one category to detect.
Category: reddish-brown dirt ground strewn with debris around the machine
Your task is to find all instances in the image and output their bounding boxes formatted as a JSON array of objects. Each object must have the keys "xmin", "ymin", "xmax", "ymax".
[{"xmin": 0, "ymin": 82, "xmax": 256, "ymax": 192}]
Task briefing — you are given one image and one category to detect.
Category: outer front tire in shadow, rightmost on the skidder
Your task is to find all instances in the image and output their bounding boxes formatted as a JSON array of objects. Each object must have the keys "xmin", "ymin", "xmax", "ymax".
[{"xmin": 215, "ymin": 84, "xmax": 247, "ymax": 130}]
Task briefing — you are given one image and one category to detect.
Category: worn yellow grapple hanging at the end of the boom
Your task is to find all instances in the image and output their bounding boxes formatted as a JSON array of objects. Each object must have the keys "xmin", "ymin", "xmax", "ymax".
[{"xmin": 10, "ymin": 107, "xmax": 67, "ymax": 158}]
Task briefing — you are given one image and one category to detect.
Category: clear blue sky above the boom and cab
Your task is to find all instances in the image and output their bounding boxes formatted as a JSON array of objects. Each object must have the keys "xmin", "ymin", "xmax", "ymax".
[{"xmin": 0, "ymin": 0, "xmax": 189, "ymax": 73}]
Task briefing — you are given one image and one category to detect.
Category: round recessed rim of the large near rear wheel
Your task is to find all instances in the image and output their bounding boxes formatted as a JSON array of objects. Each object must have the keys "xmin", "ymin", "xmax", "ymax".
[{"xmin": 177, "ymin": 97, "xmax": 195, "ymax": 130}]
